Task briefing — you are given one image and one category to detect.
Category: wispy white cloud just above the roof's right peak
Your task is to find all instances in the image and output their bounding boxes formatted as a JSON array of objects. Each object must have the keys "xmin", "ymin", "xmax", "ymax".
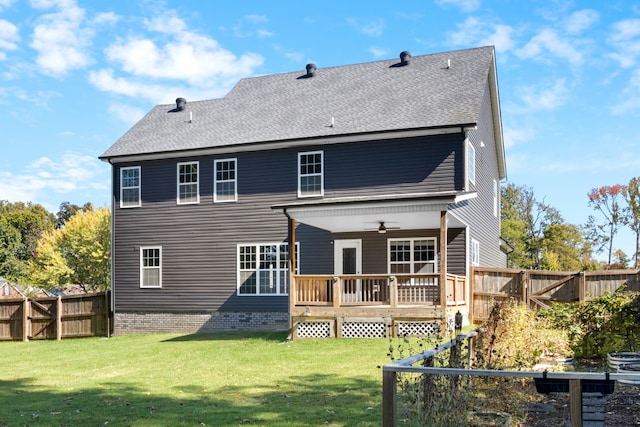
[{"xmin": 447, "ymin": 16, "xmax": 513, "ymax": 53}]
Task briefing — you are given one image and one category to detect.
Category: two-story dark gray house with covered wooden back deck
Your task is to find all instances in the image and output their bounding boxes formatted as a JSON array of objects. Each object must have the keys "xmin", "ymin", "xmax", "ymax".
[{"xmin": 100, "ymin": 46, "xmax": 506, "ymax": 337}]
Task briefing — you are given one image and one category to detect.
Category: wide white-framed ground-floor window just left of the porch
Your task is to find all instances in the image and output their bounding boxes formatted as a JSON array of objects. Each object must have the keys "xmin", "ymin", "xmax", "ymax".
[{"xmin": 238, "ymin": 243, "xmax": 299, "ymax": 295}]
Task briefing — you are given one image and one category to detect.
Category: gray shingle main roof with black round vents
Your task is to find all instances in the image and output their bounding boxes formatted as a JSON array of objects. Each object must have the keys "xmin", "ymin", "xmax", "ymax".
[{"xmin": 101, "ymin": 46, "xmax": 495, "ymax": 159}]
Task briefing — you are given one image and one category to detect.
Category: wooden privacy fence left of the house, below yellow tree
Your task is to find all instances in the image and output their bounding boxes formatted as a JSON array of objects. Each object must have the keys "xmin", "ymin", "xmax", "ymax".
[{"xmin": 0, "ymin": 292, "xmax": 112, "ymax": 341}]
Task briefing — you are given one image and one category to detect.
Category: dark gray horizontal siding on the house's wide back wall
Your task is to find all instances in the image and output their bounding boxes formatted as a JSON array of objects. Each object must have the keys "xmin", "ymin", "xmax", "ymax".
[{"xmin": 113, "ymin": 134, "xmax": 464, "ymax": 312}]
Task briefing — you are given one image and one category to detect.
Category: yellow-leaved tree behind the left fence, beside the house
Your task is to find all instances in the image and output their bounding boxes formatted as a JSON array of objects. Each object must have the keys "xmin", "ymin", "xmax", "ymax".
[{"xmin": 29, "ymin": 208, "xmax": 111, "ymax": 291}]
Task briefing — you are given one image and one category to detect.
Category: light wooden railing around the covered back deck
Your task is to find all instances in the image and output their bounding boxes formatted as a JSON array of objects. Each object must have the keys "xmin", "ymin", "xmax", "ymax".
[{"xmin": 291, "ymin": 273, "xmax": 467, "ymax": 307}]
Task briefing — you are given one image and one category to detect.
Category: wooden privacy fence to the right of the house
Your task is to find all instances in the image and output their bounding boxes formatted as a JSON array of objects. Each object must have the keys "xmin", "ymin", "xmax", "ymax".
[{"xmin": 471, "ymin": 267, "xmax": 640, "ymax": 323}]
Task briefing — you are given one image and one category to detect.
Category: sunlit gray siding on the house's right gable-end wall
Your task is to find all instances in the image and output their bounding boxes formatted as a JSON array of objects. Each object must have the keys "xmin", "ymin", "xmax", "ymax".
[{"xmin": 453, "ymin": 84, "xmax": 506, "ymax": 267}]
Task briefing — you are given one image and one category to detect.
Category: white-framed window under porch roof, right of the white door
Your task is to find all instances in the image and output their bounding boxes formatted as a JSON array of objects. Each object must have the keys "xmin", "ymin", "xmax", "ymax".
[{"xmin": 389, "ymin": 238, "xmax": 437, "ymax": 285}]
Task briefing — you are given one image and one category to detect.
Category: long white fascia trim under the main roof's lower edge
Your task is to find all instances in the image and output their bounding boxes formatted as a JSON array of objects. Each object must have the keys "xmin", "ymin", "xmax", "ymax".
[{"xmin": 101, "ymin": 126, "xmax": 464, "ymax": 163}]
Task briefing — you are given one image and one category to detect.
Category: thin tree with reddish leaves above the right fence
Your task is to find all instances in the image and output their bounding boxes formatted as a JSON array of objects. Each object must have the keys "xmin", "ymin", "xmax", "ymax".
[{"xmin": 587, "ymin": 184, "xmax": 627, "ymax": 264}]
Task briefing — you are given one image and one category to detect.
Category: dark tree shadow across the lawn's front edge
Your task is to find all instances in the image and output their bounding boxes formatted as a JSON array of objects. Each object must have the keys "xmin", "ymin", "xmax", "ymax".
[{"xmin": 0, "ymin": 375, "xmax": 381, "ymax": 427}]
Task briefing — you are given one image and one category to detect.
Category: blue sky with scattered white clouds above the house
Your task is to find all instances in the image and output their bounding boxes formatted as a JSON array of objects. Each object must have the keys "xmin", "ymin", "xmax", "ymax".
[{"xmin": 0, "ymin": 0, "xmax": 640, "ymax": 255}]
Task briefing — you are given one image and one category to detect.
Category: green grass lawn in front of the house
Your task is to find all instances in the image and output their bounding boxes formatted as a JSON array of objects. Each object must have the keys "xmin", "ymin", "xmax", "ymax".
[{"xmin": 0, "ymin": 333, "xmax": 389, "ymax": 426}]
